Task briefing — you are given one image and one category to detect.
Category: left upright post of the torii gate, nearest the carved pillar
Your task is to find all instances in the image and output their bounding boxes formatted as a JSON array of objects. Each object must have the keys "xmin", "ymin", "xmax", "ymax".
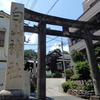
[{"xmin": 37, "ymin": 21, "xmax": 46, "ymax": 100}]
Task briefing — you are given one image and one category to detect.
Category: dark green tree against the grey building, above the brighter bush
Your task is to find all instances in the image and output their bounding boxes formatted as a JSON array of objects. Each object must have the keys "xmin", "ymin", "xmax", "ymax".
[{"xmin": 71, "ymin": 49, "xmax": 85, "ymax": 63}]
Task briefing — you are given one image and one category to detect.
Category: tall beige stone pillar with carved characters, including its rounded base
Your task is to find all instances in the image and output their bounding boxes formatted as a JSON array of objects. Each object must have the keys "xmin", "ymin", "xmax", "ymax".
[{"xmin": 0, "ymin": 2, "xmax": 28, "ymax": 100}]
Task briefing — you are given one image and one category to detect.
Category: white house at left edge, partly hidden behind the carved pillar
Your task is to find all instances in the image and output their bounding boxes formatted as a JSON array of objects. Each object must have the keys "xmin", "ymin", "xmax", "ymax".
[{"xmin": 0, "ymin": 10, "xmax": 10, "ymax": 91}]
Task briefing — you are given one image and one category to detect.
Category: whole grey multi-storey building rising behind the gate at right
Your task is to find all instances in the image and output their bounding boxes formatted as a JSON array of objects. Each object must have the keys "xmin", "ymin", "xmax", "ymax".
[{"xmin": 68, "ymin": 0, "xmax": 100, "ymax": 66}]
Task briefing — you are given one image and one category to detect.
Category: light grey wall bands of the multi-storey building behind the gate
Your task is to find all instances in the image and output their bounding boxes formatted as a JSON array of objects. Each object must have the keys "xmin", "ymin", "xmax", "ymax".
[{"xmin": 68, "ymin": 0, "xmax": 100, "ymax": 66}]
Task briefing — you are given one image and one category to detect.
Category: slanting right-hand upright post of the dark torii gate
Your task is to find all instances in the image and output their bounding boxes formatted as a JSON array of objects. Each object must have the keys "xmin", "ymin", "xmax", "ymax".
[{"xmin": 85, "ymin": 29, "xmax": 100, "ymax": 96}]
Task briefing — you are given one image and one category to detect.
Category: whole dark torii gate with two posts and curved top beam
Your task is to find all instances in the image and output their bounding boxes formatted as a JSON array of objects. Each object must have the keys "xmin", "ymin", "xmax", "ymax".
[{"xmin": 24, "ymin": 4, "xmax": 100, "ymax": 100}]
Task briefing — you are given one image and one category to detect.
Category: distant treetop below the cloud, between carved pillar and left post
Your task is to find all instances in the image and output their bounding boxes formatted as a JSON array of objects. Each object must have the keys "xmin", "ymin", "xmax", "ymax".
[{"xmin": 24, "ymin": 49, "xmax": 37, "ymax": 61}]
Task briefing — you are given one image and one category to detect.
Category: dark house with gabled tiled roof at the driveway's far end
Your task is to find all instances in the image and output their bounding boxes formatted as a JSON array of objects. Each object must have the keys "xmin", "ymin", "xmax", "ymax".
[{"xmin": 46, "ymin": 50, "xmax": 70, "ymax": 73}]
